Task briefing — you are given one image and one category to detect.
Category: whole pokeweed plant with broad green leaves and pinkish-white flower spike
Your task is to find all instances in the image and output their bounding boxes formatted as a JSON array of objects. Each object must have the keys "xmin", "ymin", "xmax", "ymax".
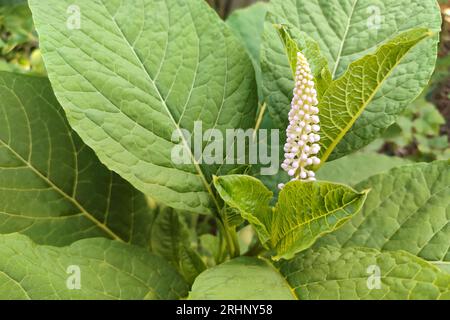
[{"xmin": 0, "ymin": 0, "xmax": 450, "ymax": 299}]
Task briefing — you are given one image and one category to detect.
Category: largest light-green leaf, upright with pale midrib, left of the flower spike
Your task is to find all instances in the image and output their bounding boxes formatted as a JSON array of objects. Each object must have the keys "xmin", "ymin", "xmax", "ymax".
[{"xmin": 29, "ymin": 0, "xmax": 257, "ymax": 213}]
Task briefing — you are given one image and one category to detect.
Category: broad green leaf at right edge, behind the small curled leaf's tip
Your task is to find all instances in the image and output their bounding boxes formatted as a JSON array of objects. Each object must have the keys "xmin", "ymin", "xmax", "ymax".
[{"xmin": 316, "ymin": 161, "xmax": 450, "ymax": 263}]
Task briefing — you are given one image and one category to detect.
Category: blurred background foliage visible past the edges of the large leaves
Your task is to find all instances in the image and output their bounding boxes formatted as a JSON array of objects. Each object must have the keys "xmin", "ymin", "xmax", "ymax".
[{"xmin": 0, "ymin": 0, "xmax": 450, "ymax": 161}]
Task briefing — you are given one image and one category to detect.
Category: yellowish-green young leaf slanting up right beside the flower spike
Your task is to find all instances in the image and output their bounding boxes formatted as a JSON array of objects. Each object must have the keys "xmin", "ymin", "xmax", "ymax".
[{"xmin": 318, "ymin": 29, "xmax": 431, "ymax": 163}]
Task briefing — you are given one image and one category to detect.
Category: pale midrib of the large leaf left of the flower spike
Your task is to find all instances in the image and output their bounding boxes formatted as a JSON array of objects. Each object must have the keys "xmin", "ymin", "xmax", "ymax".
[{"xmin": 100, "ymin": 0, "xmax": 220, "ymax": 212}]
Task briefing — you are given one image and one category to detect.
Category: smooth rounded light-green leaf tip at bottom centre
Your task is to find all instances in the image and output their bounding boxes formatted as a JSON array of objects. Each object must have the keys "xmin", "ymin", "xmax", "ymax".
[{"xmin": 189, "ymin": 257, "xmax": 296, "ymax": 300}]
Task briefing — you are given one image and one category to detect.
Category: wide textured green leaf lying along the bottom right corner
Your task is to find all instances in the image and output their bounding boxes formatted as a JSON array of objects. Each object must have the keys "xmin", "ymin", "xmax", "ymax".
[{"xmin": 277, "ymin": 247, "xmax": 450, "ymax": 300}]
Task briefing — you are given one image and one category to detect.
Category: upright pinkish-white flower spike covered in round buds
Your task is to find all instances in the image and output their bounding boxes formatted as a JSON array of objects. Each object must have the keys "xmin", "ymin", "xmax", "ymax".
[{"xmin": 279, "ymin": 52, "xmax": 320, "ymax": 189}]
